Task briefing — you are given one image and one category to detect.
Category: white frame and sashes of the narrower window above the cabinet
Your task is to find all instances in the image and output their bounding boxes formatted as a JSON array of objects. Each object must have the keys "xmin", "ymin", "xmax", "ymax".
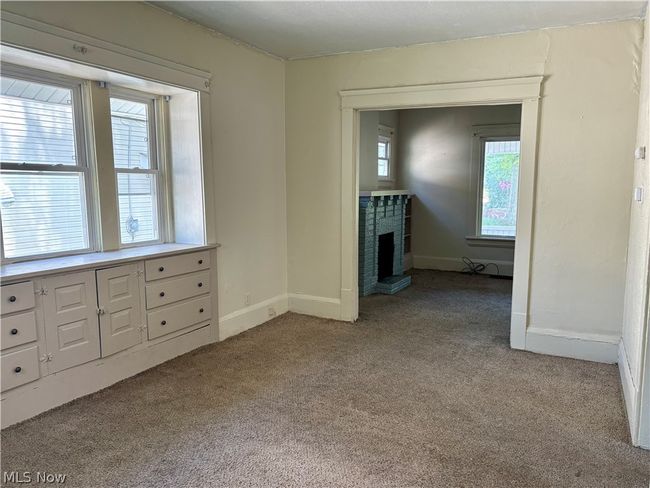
[{"xmin": 109, "ymin": 86, "xmax": 169, "ymax": 249}]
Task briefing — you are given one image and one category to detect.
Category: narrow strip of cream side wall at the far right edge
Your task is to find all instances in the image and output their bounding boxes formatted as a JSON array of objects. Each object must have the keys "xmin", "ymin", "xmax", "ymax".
[{"xmin": 619, "ymin": 7, "xmax": 650, "ymax": 448}]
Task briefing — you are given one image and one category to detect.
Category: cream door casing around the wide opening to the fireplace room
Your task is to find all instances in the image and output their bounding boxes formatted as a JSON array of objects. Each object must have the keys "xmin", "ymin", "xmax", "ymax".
[{"xmin": 339, "ymin": 76, "xmax": 543, "ymax": 349}]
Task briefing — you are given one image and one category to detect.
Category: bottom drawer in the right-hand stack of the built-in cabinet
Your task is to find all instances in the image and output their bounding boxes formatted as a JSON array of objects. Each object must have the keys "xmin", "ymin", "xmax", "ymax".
[{"xmin": 147, "ymin": 295, "xmax": 212, "ymax": 340}]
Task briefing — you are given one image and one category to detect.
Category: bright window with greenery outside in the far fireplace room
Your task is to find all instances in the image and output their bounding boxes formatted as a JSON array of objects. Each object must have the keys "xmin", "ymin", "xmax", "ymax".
[{"xmin": 477, "ymin": 137, "xmax": 520, "ymax": 238}]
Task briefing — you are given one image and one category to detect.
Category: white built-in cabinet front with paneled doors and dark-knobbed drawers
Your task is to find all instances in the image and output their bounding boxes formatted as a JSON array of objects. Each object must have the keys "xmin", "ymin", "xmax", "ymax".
[{"xmin": 0, "ymin": 249, "xmax": 215, "ymax": 395}]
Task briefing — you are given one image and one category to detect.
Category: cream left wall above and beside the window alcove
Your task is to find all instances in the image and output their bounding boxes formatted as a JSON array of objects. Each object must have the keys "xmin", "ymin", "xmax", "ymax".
[{"xmin": 2, "ymin": 2, "xmax": 287, "ymax": 327}]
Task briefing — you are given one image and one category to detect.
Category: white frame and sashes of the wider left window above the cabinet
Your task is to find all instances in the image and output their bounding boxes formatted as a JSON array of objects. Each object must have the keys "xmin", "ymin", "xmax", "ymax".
[{"xmin": 0, "ymin": 63, "xmax": 98, "ymax": 264}]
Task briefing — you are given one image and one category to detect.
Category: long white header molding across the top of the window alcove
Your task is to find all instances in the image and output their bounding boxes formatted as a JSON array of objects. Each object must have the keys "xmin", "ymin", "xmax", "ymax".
[{"xmin": 1, "ymin": 12, "xmax": 212, "ymax": 91}]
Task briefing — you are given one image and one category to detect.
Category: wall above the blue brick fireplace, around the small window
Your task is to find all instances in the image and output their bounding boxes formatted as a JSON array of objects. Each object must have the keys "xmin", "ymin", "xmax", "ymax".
[{"xmin": 359, "ymin": 110, "xmax": 399, "ymax": 190}]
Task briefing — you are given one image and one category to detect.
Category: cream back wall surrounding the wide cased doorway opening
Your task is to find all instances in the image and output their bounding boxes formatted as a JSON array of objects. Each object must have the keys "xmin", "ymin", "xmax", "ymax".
[{"xmin": 286, "ymin": 21, "xmax": 642, "ymax": 341}]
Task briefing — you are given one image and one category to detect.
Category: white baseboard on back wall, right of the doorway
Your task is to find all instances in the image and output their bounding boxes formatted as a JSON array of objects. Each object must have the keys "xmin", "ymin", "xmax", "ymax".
[{"xmin": 526, "ymin": 327, "xmax": 621, "ymax": 364}]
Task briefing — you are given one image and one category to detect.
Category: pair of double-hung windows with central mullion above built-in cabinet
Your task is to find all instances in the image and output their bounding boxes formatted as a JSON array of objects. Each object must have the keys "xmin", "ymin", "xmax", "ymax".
[{"xmin": 0, "ymin": 65, "xmax": 177, "ymax": 263}]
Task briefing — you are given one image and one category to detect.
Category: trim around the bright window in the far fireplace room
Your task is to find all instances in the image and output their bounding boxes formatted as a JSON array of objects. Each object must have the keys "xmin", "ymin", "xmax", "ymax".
[{"xmin": 465, "ymin": 124, "xmax": 521, "ymax": 248}]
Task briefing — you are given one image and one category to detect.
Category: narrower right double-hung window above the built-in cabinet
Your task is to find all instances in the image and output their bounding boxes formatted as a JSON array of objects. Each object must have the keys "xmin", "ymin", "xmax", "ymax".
[{"xmin": 110, "ymin": 91, "xmax": 162, "ymax": 246}]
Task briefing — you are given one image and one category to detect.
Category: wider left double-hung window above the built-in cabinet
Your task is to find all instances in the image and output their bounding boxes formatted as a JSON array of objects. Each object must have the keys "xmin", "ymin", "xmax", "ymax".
[{"xmin": 0, "ymin": 69, "xmax": 95, "ymax": 260}]
